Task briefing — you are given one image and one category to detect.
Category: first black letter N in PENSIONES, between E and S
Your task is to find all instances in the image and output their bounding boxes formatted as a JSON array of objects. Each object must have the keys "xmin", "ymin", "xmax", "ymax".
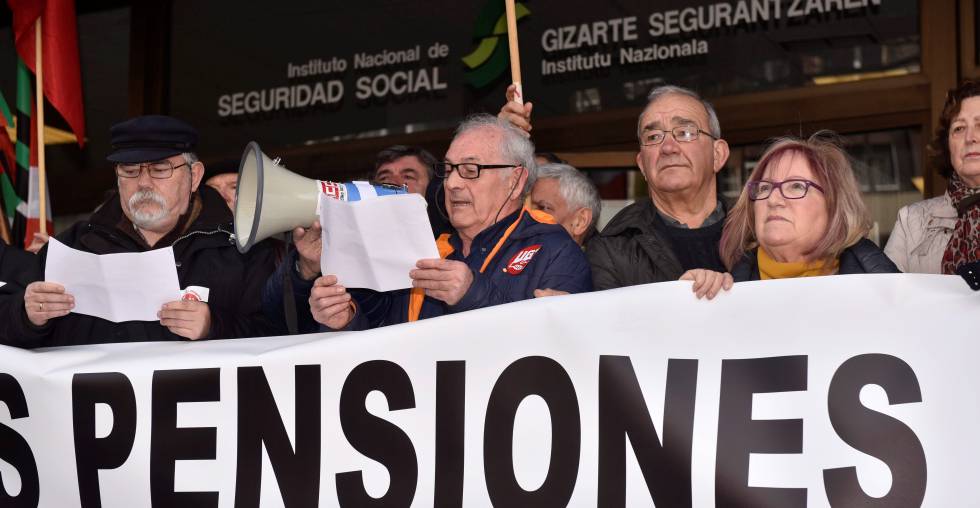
[{"xmin": 235, "ymin": 365, "xmax": 320, "ymax": 508}]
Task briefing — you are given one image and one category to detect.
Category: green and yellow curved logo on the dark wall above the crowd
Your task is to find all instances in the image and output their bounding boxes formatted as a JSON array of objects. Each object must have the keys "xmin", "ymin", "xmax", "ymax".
[{"xmin": 463, "ymin": 0, "xmax": 531, "ymax": 88}]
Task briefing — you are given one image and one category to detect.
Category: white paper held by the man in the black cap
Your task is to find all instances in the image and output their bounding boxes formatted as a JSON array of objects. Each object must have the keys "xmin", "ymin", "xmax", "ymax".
[{"xmin": 44, "ymin": 238, "xmax": 180, "ymax": 323}]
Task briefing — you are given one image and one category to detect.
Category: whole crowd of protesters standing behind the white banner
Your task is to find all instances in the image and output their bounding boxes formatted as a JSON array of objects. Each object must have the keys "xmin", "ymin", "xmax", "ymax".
[{"xmin": 0, "ymin": 82, "xmax": 980, "ymax": 348}]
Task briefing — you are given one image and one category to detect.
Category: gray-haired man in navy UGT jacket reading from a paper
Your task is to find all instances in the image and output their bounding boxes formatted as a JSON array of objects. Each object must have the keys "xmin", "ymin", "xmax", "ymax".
[{"xmin": 310, "ymin": 115, "xmax": 592, "ymax": 330}]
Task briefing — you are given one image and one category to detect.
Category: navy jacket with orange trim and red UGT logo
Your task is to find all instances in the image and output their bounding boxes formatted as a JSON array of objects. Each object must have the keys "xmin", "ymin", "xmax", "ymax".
[{"xmin": 348, "ymin": 209, "xmax": 592, "ymax": 330}]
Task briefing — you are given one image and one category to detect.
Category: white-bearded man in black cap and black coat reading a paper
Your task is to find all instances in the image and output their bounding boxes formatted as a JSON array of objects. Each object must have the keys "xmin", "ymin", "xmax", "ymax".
[{"xmin": 0, "ymin": 115, "xmax": 275, "ymax": 347}]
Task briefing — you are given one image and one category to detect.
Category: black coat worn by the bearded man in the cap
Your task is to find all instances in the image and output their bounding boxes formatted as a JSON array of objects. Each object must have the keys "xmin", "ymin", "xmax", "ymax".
[{"xmin": 0, "ymin": 185, "xmax": 275, "ymax": 347}]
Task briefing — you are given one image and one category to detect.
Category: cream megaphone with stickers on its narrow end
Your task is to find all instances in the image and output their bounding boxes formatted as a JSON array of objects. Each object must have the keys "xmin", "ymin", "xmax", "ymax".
[{"xmin": 235, "ymin": 141, "xmax": 406, "ymax": 253}]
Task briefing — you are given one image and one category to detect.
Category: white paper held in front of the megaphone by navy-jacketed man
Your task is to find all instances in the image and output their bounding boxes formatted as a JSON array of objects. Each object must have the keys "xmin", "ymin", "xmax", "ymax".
[{"xmin": 320, "ymin": 194, "xmax": 439, "ymax": 291}]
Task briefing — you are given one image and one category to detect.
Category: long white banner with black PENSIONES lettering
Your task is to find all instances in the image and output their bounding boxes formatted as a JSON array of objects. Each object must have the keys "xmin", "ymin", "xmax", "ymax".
[{"xmin": 0, "ymin": 275, "xmax": 980, "ymax": 507}]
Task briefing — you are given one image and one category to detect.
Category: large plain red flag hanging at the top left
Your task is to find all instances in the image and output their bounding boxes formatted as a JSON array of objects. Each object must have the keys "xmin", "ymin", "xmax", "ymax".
[{"xmin": 7, "ymin": 0, "xmax": 85, "ymax": 146}]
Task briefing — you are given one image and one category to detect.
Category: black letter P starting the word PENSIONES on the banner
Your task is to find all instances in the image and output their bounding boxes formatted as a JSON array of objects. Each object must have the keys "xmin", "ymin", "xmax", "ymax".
[{"xmin": 71, "ymin": 372, "xmax": 136, "ymax": 508}]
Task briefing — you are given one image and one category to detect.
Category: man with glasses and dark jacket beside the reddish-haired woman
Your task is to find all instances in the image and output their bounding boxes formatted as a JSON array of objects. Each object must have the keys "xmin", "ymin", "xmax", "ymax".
[{"xmin": 586, "ymin": 86, "xmax": 731, "ymax": 296}]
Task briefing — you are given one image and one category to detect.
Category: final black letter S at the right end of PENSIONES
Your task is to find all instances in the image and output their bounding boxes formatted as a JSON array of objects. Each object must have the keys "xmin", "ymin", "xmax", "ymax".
[{"xmin": 823, "ymin": 354, "xmax": 926, "ymax": 506}]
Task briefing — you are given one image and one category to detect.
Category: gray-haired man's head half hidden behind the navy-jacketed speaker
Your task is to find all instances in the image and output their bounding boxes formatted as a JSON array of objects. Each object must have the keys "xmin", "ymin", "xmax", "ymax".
[{"xmin": 531, "ymin": 164, "xmax": 602, "ymax": 247}]
